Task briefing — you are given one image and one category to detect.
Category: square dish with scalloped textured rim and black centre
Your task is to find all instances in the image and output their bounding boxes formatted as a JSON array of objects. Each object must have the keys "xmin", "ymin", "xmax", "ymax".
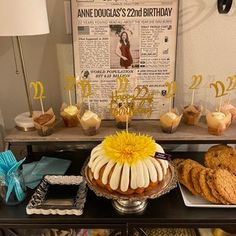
[{"xmin": 26, "ymin": 175, "xmax": 87, "ymax": 215}]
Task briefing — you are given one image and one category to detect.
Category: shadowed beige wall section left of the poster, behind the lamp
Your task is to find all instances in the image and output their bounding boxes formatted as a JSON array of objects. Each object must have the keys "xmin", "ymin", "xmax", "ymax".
[{"xmin": 0, "ymin": 0, "xmax": 73, "ymax": 129}]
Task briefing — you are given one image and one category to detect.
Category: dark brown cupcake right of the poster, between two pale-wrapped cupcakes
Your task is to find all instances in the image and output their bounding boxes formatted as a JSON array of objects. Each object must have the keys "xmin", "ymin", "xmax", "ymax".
[{"xmin": 183, "ymin": 105, "xmax": 202, "ymax": 125}]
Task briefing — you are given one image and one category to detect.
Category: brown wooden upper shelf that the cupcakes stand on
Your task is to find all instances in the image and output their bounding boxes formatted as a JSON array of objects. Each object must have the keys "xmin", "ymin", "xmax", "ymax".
[{"xmin": 5, "ymin": 119, "xmax": 236, "ymax": 145}]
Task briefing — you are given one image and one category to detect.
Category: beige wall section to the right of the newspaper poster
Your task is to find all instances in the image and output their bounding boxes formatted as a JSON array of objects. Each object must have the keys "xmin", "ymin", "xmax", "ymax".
[{"xmin": 176, "ymin": 0, "xmax": 236, "ymax": 109}]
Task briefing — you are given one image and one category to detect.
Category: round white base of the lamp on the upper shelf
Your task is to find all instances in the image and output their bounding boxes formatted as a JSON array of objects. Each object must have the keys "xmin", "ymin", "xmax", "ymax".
[{"xmin": 15, "ymin": 112, "xmax": 35, "ymax": 132}]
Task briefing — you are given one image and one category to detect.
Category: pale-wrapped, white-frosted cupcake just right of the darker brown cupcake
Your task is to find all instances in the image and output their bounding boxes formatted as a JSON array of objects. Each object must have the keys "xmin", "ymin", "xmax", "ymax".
[{"xmin": 206, "ymin": 110, "xmax": 232, "ymax": 135}]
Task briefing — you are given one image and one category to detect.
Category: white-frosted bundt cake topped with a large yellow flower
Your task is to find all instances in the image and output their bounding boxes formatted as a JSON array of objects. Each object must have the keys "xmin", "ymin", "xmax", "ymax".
[{"xmin": 88, "ymin": 131, "xmax": 169, "ymax": 194}]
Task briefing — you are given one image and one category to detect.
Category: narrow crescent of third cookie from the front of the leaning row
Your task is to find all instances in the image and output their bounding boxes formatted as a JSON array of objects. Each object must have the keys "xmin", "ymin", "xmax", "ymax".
[{"xmin": 199, "ymin": 168, "xmax": 220, "ymax": 203}]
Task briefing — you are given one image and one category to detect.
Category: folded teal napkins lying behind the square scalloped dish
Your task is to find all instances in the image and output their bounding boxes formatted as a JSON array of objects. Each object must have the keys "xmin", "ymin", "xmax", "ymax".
[{"xmin": 23, "ymin": 156, "xmax": 71, "ymax": 189}]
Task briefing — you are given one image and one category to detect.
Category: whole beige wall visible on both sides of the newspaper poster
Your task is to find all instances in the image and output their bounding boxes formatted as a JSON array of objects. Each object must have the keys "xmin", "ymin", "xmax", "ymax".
[{"xmin": 0, "ymin": 0, "xmax": 236, "ymax": 131}]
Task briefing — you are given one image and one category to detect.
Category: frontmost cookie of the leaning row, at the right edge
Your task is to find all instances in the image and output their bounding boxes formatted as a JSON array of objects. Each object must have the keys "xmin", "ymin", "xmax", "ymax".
[{"xmin": 214, "ymin": 169, "xmax": 236, "ymax": 204}]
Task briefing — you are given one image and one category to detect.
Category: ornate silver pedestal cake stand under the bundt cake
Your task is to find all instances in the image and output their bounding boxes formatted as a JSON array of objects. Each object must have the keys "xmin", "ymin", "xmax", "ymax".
[{"xmin": 82, "ymin": 160, "xmax": 177, "ymax": 214}]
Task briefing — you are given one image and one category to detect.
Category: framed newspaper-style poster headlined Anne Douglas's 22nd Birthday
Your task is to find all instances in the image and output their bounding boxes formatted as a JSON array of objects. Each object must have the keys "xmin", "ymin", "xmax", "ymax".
[{"xmin": 72, "ymin": 0, "xmax": 178, "ymax": 119}]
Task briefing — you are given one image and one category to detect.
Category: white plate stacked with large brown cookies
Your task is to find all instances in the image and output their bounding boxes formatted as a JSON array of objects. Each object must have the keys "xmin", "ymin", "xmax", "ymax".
[{"xmin": 173, "ymin": 145, "xmax": 236, "ymax": 208}]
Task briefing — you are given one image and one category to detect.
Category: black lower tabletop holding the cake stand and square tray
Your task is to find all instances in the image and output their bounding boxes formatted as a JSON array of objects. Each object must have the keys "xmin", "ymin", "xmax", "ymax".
[{"xmin": 0, "ymin": 150, "xmax": 236, "ymax": 228}]
